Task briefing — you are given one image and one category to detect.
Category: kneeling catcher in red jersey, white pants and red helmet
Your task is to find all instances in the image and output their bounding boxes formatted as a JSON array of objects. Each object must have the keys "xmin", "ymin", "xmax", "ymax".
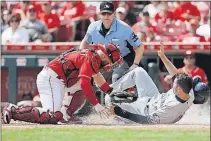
[{"xmin": 2, "ymin": 43, "xmax": 122, "ymax": 124}]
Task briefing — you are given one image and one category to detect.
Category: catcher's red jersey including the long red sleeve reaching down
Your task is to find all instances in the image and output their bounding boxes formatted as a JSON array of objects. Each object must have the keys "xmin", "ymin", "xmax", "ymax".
[{"xmin": 47, "ymin": 49, "xmax": 101, "ymax": 106}]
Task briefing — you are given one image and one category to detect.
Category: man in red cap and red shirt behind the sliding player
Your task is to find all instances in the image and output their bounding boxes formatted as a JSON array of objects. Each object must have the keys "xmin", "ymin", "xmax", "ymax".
[{"xmin": 164, "ymin": 50, "xmax": 208, "ymax": 84}]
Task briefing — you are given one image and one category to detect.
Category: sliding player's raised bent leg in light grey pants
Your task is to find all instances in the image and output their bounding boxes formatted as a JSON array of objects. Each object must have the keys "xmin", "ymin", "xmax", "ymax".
[{"xmin": 111, "ymin": 67, "xmax": 159, "ymax": 97}]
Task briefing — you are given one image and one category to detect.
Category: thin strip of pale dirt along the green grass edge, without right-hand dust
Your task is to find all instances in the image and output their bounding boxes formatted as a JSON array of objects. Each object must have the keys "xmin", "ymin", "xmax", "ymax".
[{"xmin": 2, "ymin": 115, "xmax": 210, "ymax": 131}]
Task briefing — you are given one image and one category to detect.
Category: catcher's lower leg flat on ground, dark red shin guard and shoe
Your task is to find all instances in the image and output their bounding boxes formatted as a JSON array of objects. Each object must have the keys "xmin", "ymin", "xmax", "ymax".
[{"xmin": 2, "ymin": 103, "xmax": 63, "ymax": 124}]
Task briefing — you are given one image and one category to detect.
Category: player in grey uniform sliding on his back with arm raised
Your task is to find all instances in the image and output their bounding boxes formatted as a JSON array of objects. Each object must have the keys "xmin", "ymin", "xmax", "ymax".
[{"xmin": 105, "ymin": 41, "xmax": 210, "ymax": 124}]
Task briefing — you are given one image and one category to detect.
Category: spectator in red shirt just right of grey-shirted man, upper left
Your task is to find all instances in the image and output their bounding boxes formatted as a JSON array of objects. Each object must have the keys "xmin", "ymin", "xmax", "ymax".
[{"xmin": 40, "ymin": 2, "xmax": 60, "ymax": 40}]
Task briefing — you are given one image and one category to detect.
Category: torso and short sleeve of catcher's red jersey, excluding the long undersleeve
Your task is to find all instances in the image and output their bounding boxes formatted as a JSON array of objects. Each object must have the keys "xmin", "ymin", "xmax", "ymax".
[{"xmin": 47, "ymin": 50, "xmax": 101, "ymax": 87}]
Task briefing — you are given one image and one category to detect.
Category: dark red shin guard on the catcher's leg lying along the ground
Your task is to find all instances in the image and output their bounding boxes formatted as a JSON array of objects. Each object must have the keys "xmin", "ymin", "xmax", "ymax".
[{"xmin": 11, "ymin": 106, "xmax": 63, "ymax": 124}]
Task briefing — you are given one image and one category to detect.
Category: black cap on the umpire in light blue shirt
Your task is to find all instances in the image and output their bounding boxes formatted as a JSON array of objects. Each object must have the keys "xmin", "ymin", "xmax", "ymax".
[{"xmin": 100, "ymin": 1, "xmax": 115, "ymax": 13}]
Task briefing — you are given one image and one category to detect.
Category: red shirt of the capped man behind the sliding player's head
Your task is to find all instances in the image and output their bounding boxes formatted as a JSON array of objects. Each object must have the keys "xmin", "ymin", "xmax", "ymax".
[{"xmin": 179, "ymin": 67, "xmax": 207, "ymax": 83}]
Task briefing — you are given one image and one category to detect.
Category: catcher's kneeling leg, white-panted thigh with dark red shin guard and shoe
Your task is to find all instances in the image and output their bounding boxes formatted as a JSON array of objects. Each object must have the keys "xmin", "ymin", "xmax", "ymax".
[{"xmin": 3, "ymin": 67, "xmax": 64, "ymax": 124}]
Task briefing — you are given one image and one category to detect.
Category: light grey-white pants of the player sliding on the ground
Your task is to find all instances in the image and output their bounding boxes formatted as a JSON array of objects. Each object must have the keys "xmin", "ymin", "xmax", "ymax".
[{"xmin": 111, "ymin": 67, "xmax": 159, "ymax": 116}]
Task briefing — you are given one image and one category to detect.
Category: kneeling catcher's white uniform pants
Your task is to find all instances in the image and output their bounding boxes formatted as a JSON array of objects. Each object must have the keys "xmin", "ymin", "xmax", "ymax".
[{"xmin": 37, "ymin": 67, "xmax": 81, "ymax": 112}]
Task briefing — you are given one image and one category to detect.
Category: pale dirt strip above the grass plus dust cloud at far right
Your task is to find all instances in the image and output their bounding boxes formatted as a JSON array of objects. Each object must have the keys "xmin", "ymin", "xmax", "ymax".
[{"xmin": 2, "ymin": 100, "xmax": 210, "ymax": 131}]
